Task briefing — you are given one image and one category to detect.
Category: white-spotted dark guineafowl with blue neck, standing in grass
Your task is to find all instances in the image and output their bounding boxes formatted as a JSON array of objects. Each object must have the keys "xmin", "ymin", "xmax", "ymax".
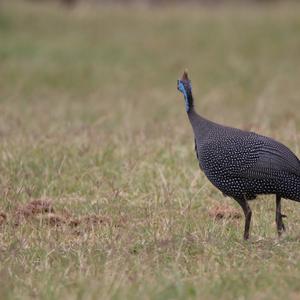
[{"xmin": 177, "ymin": 70, "xmax": 300, "ymax": 240}]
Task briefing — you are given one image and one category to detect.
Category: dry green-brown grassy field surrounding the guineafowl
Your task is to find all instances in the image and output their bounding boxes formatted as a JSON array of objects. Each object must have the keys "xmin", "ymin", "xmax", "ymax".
[{"xmin": 0, "ymin": 1, "xmax": 300, "ymax": 299}]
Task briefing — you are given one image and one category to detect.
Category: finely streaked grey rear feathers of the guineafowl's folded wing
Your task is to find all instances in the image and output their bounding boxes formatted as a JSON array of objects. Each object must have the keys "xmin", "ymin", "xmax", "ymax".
[{"xmin": 240, "ymin": 135, "xmax": 300, "ymax": 178}]
